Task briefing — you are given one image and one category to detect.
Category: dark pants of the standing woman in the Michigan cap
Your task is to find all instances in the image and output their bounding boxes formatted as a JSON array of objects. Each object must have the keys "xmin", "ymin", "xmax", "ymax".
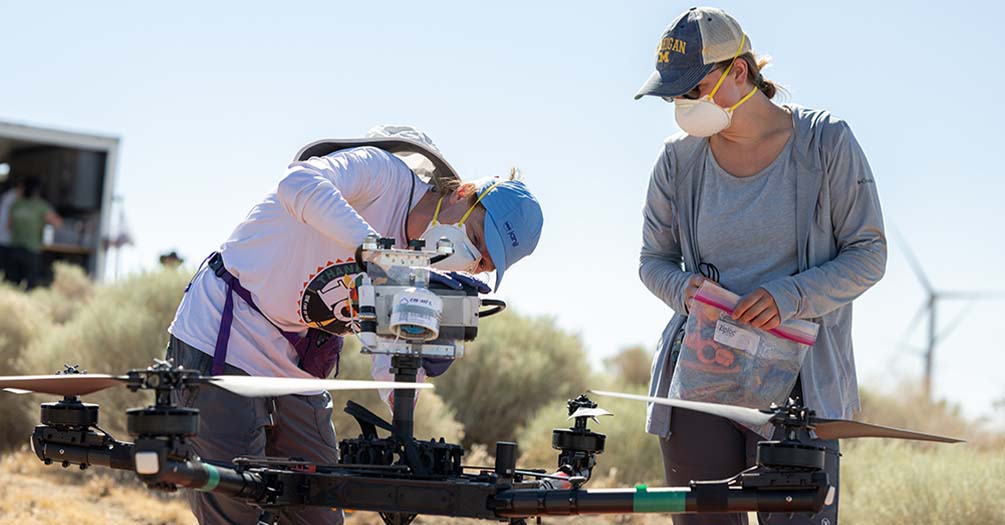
[{"xmin": 659, "ymin": 408, "xmax": 840, "ymax": 525}]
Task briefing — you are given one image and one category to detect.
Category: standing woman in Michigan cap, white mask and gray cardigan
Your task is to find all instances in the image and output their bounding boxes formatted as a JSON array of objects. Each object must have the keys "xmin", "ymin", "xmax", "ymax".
[{"xmin": 635, "ymin": 7, "xmax": 886, "ymax": 525}]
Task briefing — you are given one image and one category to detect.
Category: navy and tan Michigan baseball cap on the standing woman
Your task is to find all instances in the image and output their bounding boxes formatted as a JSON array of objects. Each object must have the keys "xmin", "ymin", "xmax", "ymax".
[{"xmin": 635, "ymin": 7, "xmax": 751, "ymax": 101}]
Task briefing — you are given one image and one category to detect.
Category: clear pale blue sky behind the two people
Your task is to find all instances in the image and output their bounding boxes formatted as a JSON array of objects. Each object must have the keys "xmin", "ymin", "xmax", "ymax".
[{"xmin": 0, "ymin": 0, "xmax": 1005, "ymax": 415}]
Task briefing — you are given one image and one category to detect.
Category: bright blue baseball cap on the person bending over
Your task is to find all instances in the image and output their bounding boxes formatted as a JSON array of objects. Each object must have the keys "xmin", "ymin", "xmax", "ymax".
[{"xmin": 478, "ymin": 180, "xmax": 545, "ymax": 291}]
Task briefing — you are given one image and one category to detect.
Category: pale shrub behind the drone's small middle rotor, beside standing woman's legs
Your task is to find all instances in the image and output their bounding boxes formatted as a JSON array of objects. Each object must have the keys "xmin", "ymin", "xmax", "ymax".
[{"xmin": 518, "ymin": 384, "xmax": 663, "ymax": 486}]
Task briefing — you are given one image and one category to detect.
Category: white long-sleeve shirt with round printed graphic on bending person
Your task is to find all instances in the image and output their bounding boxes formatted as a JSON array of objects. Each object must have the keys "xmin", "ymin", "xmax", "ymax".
[{"xmin": 168, "ymin": 147, "xmax": 430, "ymax": 377}]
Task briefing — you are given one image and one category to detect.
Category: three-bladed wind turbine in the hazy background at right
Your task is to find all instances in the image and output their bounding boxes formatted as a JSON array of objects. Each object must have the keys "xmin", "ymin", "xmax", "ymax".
[{"xmin": 897, "ymin": 234, "xmax": 1005, "ymax": 400}]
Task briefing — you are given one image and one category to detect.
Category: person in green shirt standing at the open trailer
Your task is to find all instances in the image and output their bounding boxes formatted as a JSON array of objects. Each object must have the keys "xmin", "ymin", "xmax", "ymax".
[{"xmin": 8, "ymin": 177, "xmax": 62, "ymax": 290}]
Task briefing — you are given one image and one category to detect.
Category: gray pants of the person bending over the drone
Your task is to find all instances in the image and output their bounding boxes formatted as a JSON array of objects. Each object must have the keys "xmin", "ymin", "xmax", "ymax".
[{"xmin": 167, "ymin": 337, "xmax": 343, "ymax": 525}]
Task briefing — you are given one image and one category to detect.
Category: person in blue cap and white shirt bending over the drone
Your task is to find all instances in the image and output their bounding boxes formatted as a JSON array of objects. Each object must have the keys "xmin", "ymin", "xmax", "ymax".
[{"xmin": 168, "ymin": 127, "xmax": 543, "ymax": 524}]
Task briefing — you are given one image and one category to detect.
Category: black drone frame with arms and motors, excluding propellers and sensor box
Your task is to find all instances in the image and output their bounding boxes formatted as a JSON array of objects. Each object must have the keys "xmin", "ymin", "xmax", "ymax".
[{"xmin": 31, "ymin": 356, "xmax": 829, "ymax": 525}]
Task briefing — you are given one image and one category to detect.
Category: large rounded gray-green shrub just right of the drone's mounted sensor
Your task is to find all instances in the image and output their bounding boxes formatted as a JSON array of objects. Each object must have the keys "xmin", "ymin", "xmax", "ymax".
[{"xmin": 434, "ymin": 311, "xmax": 590, "ymax": 449}]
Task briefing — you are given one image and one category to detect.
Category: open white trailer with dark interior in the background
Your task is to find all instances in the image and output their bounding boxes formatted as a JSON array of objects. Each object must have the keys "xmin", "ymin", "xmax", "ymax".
[{"xmin": 0, "ymin": 121, "xmax": 119, "ymax": 280}]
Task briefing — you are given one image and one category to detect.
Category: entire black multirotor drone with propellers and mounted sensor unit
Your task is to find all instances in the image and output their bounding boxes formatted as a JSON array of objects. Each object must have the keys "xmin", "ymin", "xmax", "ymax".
[{"xmin": 0, "ymin": 237, "xmax": 962, "ymax": 525}]
